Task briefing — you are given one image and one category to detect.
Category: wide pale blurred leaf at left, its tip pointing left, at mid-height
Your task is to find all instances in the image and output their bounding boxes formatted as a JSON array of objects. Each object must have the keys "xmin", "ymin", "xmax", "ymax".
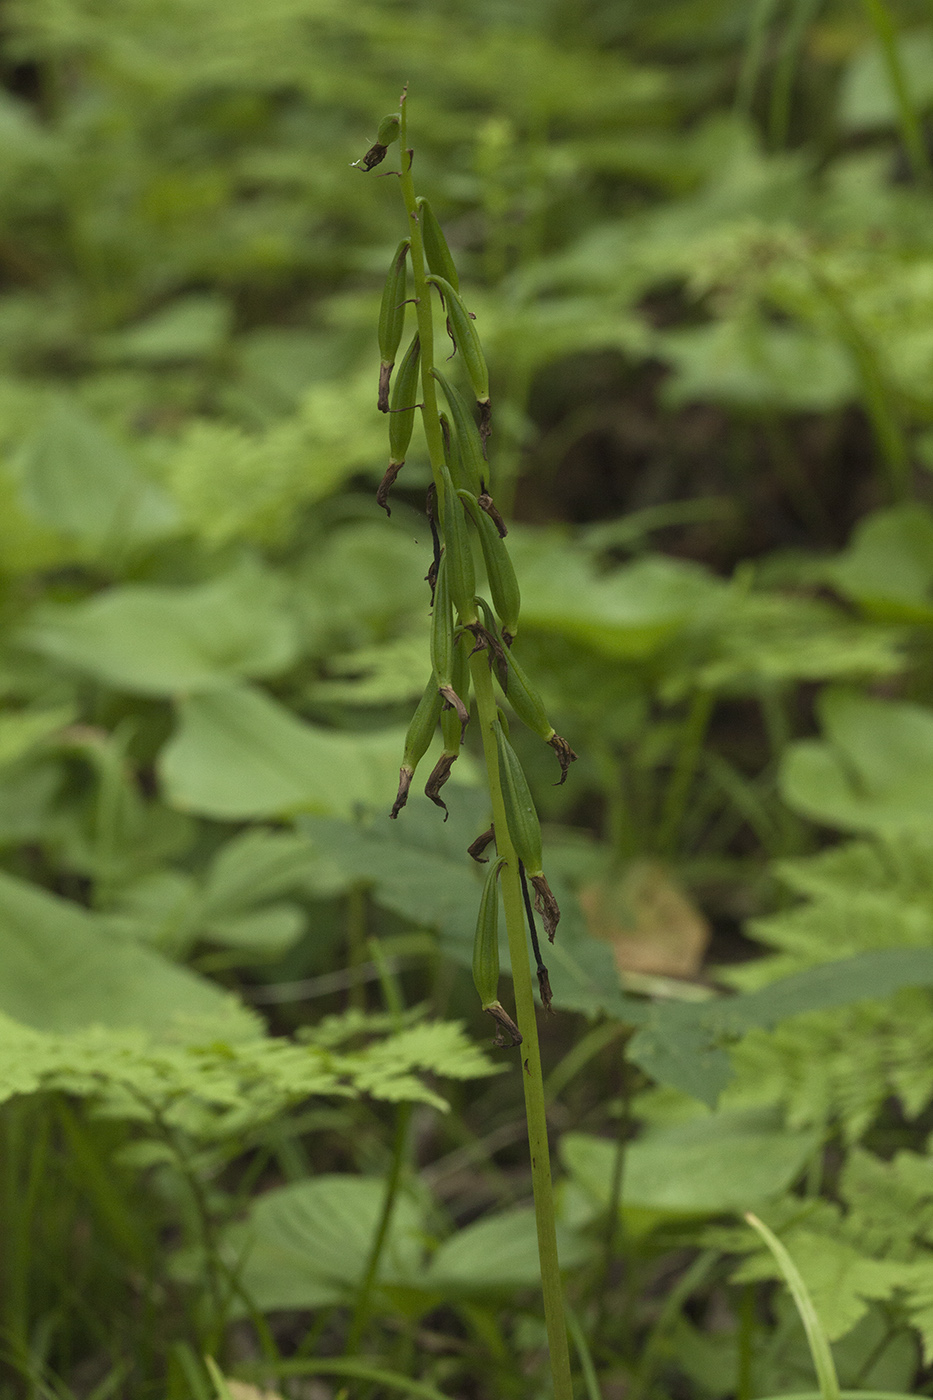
[{"xmin": 22, "ymin": 566, "xmax": 297, "ymax": 696}]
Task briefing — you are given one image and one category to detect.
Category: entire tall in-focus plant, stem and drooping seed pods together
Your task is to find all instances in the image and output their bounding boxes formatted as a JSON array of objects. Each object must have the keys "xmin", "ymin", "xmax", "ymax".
[{"xmin": 359, "ymin": 94, "xmax": 576, "ymax": 1400}]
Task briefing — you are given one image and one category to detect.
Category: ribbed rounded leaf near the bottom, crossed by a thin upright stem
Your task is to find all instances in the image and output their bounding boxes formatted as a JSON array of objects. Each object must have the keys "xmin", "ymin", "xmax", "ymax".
[{"xmin": 226, "ymin": 1176, "xmax": 424, "ymax": 1312}]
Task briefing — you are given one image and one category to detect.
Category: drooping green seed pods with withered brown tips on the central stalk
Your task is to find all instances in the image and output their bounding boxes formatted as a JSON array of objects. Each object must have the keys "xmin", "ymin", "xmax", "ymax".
[{"xmin": 357, "ymin": 113, "xmax": 576, "ymax": 1043}]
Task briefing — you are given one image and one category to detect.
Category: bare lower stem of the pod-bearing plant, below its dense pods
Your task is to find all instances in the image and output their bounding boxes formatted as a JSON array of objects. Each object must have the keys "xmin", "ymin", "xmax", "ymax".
[{"xmin": 469, "ymin": 651, "xmax": 573, "ymax": 1400}]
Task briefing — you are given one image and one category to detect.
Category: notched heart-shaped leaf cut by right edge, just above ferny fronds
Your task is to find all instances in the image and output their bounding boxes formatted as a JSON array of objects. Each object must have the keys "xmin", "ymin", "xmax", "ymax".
[{"xmin": 780, "ymin": 692, "xmax": 933, "ymax": 836}]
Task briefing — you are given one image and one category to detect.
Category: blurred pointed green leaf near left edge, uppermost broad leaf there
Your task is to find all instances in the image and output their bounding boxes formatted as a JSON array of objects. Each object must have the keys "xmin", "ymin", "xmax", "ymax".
[{"xmin": 14, "ymin": 398, "xmax": 177, "ymax": 553}]
